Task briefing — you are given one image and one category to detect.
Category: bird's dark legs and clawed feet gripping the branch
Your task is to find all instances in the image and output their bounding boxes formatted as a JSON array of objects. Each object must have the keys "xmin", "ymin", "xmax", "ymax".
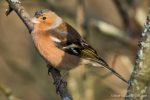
[{"xmin": 47, "ymin": 65, "xmax": 67, "ymax": 93}]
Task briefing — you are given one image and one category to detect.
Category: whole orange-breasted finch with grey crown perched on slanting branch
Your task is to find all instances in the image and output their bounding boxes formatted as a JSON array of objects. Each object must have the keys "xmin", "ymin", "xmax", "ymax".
[{"xmin": 31, "ymin": 9, "xmax": 128, "ymax": 84}]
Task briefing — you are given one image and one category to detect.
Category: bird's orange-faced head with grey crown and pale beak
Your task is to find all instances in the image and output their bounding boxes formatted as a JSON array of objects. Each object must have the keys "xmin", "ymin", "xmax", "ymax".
[{"xmin": 31, "ymin": 9, "xmax": 62, "ymax": 30}]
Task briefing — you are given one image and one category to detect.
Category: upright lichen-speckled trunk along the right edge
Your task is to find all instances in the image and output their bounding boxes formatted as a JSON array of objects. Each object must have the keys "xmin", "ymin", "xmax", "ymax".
[{"xmin": 125, "ymin": 9, "xmax": 150, "ymax": 100}]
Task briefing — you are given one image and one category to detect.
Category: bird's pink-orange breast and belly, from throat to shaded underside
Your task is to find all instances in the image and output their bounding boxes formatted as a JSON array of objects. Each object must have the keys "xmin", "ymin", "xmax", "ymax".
[{"xmin": 32, "ymin": 32, "xmax": 80, "ymax": 69}]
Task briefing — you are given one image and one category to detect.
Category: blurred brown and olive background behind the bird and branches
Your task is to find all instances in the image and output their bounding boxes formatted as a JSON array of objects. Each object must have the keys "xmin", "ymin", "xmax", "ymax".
[{"xmin": 0, "ymin": 0, "xmax": 150, "ymax": 100}]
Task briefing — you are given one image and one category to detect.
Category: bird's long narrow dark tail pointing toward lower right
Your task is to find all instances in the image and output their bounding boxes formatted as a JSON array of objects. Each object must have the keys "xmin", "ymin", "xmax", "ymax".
[{"xmin": 93, "ymin": 58, "xmax": 129, "ymax": 84}]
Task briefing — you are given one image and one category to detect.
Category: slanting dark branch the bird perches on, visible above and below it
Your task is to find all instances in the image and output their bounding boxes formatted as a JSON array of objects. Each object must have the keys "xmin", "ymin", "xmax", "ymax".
[{"xmin": 6, "ymin": 0, "xmax": 72, "ymax": 100}]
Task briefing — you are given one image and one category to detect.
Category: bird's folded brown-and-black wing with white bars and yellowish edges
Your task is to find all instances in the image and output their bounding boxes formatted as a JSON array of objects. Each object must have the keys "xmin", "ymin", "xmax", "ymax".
[{"xmin": 50, "ymin": 23, "xmax": 99, "ymax": 59}]
